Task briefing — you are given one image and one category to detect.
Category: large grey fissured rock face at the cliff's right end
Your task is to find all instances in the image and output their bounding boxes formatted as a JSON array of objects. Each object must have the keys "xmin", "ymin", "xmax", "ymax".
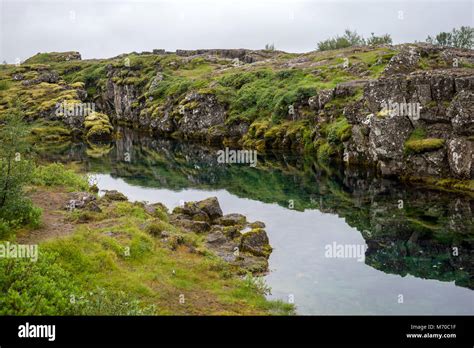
[{"xmin": 345, "ymin": 67, "xmax": 474, "ymax": 179}]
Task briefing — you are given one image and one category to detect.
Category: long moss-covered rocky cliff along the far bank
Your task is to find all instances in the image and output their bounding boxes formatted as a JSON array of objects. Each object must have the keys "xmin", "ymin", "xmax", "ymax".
[{"xmin": 0, "ymin": 44, "xmax": 474, "ymax": 190}]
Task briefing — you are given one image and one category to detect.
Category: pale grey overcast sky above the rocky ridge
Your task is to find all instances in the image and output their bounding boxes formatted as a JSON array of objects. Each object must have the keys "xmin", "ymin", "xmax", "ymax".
[{"xmin": 0, "ymin": 0, "xmax": 474, "ymax": 63}]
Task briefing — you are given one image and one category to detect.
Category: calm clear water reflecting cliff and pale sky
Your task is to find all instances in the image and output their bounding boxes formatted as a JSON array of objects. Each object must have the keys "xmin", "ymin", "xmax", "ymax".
[{"xmin": 41, "ymin": 132, "xmax": 474, "ymax": 315}]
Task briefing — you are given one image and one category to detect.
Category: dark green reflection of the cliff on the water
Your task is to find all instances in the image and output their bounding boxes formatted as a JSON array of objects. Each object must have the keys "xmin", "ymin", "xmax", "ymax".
[{"xmin": 38, "ymin": 129, "xmax": 474, "ymax": 314}]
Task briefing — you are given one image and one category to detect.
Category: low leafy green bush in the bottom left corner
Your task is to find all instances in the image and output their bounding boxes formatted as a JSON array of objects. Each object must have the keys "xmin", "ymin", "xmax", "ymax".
[{"xmin": 0, "ymin": 251, "xmax": 155, "ymax": 315}]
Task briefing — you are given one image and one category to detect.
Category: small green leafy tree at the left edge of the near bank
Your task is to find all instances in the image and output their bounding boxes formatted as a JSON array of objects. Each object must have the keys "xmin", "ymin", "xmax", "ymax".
[{"xmin": 0, "ymin": 105, "xmax": 40, "ymax": 235}]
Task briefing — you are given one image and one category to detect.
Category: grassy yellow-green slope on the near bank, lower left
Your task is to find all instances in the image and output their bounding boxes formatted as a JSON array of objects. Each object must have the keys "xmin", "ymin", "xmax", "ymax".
[{"xmin": 0, "ymin": 165, "xmax": 293, "ymax": 315}]
